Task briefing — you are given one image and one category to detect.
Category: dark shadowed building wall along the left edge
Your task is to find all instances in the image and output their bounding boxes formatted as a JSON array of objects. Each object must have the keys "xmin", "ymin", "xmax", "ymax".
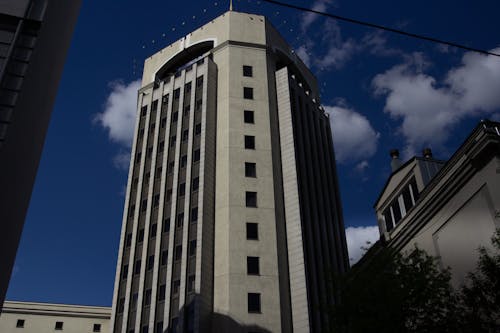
[{"xmin": 0, "ymin": 0, "xmax": 81, "ymax": 308}]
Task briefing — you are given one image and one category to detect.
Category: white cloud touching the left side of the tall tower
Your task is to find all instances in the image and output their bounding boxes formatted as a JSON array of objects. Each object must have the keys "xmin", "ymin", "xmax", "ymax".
[{"xmin": 95, "ymin": 80, "xmax": 141, "ymax": 147}]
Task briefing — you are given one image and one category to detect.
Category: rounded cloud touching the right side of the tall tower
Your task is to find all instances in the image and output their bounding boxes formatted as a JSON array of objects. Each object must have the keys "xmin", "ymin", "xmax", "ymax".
[{"xmin": 325, "ymin": 106, "xmax": 380, "ymax": 162}]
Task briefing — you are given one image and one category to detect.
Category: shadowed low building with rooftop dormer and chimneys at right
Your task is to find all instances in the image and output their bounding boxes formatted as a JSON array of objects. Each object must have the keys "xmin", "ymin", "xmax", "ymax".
[{"xmin": 374, "ymin": 121, "xmax": 500, "ymax": 286}]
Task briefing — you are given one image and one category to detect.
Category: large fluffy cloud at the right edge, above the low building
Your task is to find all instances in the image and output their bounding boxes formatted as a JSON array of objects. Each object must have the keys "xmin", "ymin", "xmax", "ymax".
[{"xmin": 372, "ymin": 49, "xmax": 500, "ymax": 156}]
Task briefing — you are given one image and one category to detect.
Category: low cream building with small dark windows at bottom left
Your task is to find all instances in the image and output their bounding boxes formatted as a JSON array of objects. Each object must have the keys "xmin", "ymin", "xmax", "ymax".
[{"xmin": 0, "ymin": 301, "xmax": 111, "ymax": 333}]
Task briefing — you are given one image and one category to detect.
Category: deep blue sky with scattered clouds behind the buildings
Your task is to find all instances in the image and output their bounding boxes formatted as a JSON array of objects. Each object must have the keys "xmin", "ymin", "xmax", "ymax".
[{"xmin": 7, "ymin": 0, "xmax": 500, "ymax": 305}]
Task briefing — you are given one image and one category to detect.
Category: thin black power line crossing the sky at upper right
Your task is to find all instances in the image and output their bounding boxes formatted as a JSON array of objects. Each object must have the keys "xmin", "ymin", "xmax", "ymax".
[{"xmin": 261, "ymin": 0, "xmax": 500, "ymax": 57}]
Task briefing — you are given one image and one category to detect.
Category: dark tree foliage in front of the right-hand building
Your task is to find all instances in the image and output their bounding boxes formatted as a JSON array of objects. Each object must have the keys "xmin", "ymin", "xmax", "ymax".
[{"xmin": 328, "ymin": 230, "xmax": 500, "ymax": 333}]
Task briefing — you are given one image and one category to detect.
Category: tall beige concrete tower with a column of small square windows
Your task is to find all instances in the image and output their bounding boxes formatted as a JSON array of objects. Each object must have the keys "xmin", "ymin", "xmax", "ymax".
[{"xmin": 111, "ymin": 11, "xmax": 348, "ymax": 333}]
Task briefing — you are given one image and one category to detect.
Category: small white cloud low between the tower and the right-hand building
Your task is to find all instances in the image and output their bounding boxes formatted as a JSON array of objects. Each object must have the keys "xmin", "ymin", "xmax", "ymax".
[{"xmin": 346, "ymin": 226, "xmax": 380, "ymax": 266}]
